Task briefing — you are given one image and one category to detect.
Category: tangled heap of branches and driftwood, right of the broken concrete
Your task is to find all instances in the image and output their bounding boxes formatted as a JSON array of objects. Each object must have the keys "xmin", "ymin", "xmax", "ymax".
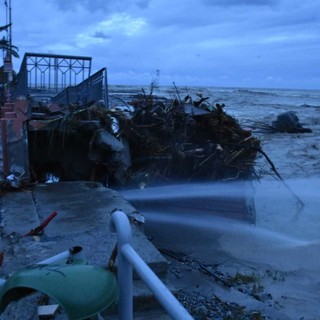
[{"xmin": 119, "ymin": 95, "xmax": 260, "ymax": 183}]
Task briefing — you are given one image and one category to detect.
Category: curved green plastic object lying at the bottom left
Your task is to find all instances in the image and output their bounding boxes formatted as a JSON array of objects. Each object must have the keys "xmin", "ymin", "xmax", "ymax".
[{"xmin": 0, "ymin": 260, "xmax": 118, "ymax": 320}]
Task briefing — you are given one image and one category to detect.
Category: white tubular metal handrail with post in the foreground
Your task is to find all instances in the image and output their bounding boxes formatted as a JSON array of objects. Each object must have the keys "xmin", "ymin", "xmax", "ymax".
[{"xmin": 111, "ymin": 211, "xmax": 193, "ymax": 320}]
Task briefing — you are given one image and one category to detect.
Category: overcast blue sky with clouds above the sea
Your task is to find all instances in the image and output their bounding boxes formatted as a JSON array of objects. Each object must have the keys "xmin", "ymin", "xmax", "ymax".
[{"xmin": 0, "ymin": 0, "xmax": 320, "ymax": 89}]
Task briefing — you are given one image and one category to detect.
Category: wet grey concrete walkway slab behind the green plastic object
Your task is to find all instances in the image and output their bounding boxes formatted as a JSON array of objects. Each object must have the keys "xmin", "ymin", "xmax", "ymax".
[{"xmin": 0, "ymin": 182, "xmax": 168, "ymax": 318}]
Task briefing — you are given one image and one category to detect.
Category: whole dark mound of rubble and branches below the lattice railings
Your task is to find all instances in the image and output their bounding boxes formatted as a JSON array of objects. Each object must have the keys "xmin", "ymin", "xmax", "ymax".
[{"xmin": 29, "ymin": 93, "xmax": 260, "ymax": 186}]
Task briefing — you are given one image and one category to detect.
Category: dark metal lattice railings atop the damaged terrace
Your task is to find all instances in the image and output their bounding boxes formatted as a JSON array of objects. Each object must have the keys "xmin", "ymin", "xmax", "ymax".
[{"xmin": 13, "ymin": 53, "xmax": 109, "ymax": 106}]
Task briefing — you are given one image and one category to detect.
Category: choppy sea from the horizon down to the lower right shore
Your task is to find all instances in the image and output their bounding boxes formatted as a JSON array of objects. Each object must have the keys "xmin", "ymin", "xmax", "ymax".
[{"xmin": 114, "ymin": 85, "xmax": 320, "ymax": 320}]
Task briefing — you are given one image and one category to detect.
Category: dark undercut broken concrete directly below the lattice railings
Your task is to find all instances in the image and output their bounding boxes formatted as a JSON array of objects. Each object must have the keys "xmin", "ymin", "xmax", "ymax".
[{"xmin": 28, "ymin": 103, "xmax": 124, "ymax": 182}]
